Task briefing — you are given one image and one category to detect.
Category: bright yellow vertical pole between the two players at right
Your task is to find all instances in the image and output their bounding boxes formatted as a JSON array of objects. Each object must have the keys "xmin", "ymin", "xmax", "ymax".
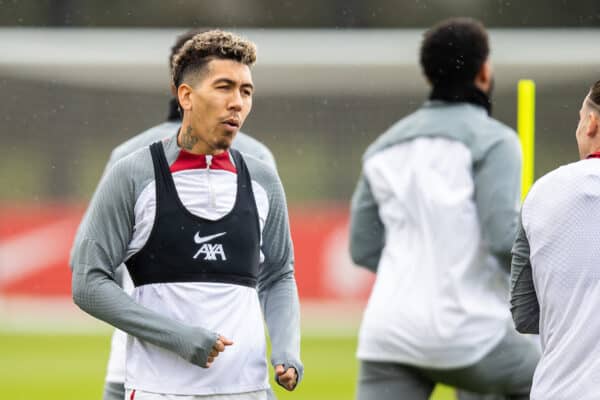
[{"xmin": 517, "ymin": 79, "xmax": 535, "ymax": 201}]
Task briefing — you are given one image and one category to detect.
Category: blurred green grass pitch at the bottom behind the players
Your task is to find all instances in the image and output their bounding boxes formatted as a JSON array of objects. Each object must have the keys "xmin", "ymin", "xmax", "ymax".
[{"xmin": 0, "ymin": 333, "xmax": 454, "ymax": 400}]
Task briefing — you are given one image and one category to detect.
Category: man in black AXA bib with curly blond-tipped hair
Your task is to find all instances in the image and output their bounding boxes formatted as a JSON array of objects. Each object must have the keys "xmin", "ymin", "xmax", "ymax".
[{"xmin": 72, "ymin": 31, "xmax": 303, "ymax": 399}]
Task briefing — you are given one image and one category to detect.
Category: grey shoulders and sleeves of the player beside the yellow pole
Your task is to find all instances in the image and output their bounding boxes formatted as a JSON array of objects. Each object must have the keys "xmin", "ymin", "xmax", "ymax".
[{"xmin": 350, "ymin": 101, "xmax": 521, "ymax": 272}]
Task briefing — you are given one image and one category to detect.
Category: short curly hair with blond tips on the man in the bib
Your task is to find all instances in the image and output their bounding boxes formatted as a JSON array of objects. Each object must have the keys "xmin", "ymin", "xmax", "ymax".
[{"xmin": 171, "ymin": 30, "xmax": 256, "ymax": 87}]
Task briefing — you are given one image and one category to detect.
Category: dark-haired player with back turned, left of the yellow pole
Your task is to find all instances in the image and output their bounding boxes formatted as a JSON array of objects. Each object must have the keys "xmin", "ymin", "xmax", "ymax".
[{"xmin": 350, "ymin": 18, "xmax": 539, "ymax": 400}]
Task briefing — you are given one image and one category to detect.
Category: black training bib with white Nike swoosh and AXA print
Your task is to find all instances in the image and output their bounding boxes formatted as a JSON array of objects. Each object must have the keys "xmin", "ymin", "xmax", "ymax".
[{"xmin": 125, "ymin": 142, "xmax": 260, "ymax": 287}]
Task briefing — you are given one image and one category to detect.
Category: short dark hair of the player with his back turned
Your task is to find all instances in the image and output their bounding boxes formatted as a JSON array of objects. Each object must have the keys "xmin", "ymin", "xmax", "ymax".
[{"xmin": 420, "ymin": 18, "xmax": 490, "ymax": 86}]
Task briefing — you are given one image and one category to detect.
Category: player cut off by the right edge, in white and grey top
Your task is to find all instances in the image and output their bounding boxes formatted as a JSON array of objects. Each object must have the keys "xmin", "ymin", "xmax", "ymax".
[{"xmin": 511, "ymin": 81, "xmax": 600, "ymax": 400}]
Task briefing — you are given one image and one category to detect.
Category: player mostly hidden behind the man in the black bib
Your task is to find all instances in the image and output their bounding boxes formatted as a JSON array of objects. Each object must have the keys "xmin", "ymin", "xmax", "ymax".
[{"xmin": 71, "ymin": 30, "xmax": 298, "ymax": 400}]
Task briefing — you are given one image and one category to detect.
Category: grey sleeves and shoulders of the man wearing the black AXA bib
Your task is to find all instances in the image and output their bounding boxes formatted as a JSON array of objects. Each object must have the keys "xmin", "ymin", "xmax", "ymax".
[{"xmin": 71, "ymin": 130, "xmax": 303, "ymax": 379}]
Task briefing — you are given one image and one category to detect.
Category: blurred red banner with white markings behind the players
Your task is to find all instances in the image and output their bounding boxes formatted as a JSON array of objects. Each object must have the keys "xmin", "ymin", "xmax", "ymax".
[{"xmin": 0, "ymin": 205, "xmax": 373, "ymax": 301}]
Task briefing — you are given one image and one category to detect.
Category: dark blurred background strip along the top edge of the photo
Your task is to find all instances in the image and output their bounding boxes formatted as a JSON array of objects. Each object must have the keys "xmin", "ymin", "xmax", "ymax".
[{"xmin": 0, "ymin": 0, "xmax": 600, "ymax": 28}]
